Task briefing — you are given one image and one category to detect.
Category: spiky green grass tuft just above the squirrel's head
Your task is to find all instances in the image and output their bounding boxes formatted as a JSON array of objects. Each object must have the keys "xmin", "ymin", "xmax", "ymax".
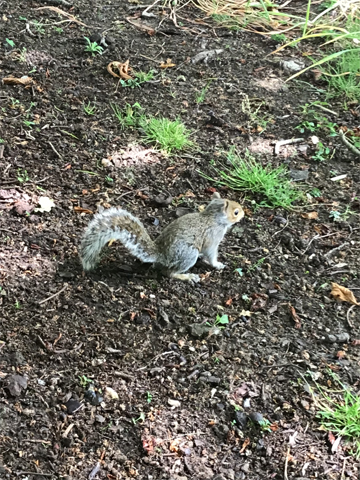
[{"xmin": 200, "ymin": 148, "xmax": 301, "ymax": 209}]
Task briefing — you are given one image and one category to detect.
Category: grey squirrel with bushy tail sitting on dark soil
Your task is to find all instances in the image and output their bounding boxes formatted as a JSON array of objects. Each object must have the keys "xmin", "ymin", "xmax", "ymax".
[{"xmin": 80, "ymin": 192, "xmax": 244, "ymax": 283}]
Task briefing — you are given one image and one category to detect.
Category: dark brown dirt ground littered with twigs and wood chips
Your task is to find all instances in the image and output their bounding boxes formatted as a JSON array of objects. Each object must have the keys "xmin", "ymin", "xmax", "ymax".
[{"xmin": 0, "ymin": 0, "xmax": 360, "ymax": 480}]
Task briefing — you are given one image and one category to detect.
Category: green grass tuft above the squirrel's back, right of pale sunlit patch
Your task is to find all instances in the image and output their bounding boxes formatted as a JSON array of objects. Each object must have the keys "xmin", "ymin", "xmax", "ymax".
[{"xmin": 142, "ymin": 117, "xmax": 193, "ymax": 153}]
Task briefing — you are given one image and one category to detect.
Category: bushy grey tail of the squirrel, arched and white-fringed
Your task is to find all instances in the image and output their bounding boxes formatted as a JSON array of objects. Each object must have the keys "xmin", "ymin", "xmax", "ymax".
[{"xmin": 80, "ymin": 207, "xmax": 157, "ymax": 270}]
